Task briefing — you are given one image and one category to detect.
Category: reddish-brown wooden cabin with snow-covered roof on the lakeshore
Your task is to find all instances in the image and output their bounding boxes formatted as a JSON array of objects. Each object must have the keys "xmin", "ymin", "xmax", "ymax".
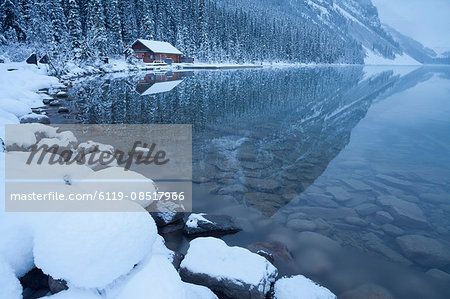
[{"xmin": 127, "ymin": 39, "xmax": 183, "ymax": 63}]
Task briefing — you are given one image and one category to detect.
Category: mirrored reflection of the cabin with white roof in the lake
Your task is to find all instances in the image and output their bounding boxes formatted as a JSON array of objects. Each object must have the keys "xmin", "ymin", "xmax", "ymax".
[{"xmin": 136, "ymin": 72, "xmax": 183, "ymax": 95}]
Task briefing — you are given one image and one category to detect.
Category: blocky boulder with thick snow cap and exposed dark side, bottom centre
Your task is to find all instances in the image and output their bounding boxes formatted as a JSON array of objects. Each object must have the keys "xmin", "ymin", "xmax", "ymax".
[{"xmin": 180, "ymin": 237, "xmax": 278, "ymax": 299}]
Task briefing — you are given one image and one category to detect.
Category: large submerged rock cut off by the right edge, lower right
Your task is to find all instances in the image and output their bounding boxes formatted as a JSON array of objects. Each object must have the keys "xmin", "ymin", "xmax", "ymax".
[{"xmin": 396, "ymin": 235, "xmax": 450, "ymax": 267}]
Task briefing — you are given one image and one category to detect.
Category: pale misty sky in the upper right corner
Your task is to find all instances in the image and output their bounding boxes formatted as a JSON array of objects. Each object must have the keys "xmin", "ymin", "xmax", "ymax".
[{"xmin": 372, "ymin": 0, "xmax": 450, "ymax": 53}]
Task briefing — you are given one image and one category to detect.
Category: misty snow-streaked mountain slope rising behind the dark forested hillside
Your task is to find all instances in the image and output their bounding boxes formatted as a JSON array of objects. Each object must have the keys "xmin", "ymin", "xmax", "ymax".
[{"xmin": 217, "ymin": 0, "xmax": 421, "ymax": 64}]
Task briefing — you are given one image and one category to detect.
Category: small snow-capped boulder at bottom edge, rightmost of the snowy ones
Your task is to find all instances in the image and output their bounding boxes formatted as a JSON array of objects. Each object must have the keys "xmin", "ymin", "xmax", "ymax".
[{"xmin": 275, "ymin": 275, "xmax": 337, "ymax": 299}]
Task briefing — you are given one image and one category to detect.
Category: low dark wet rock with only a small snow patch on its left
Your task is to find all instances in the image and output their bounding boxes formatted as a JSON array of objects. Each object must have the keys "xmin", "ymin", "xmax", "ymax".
[{"xmin": 184, "ymin": 214, "xmax": 242, "ymax": 237}]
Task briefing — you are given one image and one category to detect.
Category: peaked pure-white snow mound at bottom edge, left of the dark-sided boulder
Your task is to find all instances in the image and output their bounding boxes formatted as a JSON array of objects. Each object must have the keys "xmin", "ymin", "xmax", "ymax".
[{"xmin": 115, "ymin": 255, "xmax": 186, "ymax": 299}]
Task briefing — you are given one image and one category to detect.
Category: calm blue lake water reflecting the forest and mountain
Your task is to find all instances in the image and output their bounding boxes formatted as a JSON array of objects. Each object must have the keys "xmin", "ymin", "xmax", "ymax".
[{"xmin": 49, "ymin": 67, "xmax": 450, "ymax": 298}]
